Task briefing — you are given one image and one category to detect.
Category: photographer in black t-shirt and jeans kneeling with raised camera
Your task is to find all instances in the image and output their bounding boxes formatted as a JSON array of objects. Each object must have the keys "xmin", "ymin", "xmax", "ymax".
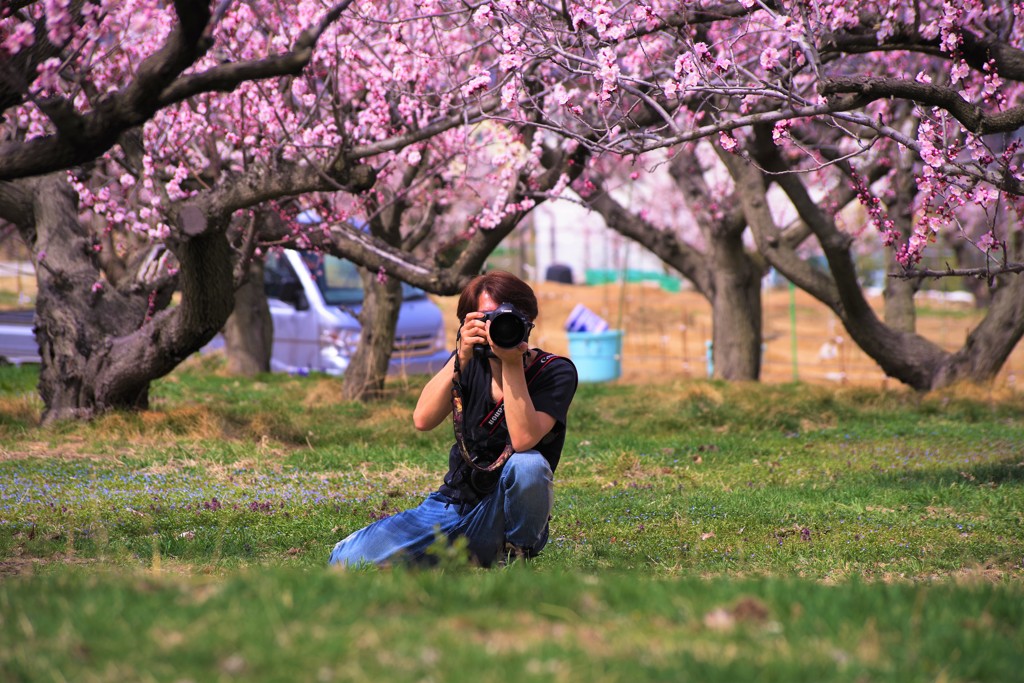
[{"xmin": 331, "ymin": 271, "xmax": 578, "ymax": 566}]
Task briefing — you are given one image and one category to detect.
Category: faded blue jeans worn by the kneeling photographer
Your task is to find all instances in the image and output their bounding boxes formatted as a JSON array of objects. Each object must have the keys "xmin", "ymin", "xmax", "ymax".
[{"xmin": 331, "ymin": 451, "xmax": 554, "ymax": 566}]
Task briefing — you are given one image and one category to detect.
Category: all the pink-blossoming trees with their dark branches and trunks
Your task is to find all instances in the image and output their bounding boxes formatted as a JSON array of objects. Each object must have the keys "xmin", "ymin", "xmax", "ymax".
[{"xmin": 0, "ymin": 0, "xmax": 1024, "ymax": 420}]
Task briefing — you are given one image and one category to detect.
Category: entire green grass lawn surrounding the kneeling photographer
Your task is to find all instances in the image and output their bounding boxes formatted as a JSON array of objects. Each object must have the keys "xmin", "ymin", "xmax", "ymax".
[{"xmin": 0, "ymin": 359, "xmax": 1024, "ymax": 681}]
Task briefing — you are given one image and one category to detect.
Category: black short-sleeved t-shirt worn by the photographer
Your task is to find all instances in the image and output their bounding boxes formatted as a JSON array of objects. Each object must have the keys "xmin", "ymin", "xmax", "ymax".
[{"xmin": 440, "ymin": 349, "xmax": 578, "ymax": 501}]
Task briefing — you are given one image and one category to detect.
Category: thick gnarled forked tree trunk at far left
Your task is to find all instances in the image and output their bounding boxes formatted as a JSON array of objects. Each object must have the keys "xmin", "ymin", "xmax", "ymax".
[{"xmin": 11, "ymin": 174, "xmax": 233, "ymax": 423}]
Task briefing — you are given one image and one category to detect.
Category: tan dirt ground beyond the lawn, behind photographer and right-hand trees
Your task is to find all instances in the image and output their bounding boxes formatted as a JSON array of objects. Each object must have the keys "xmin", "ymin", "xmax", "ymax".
[{"xmin": 435, "ymin": 282, "xmax": 1024, "ymax": 389}]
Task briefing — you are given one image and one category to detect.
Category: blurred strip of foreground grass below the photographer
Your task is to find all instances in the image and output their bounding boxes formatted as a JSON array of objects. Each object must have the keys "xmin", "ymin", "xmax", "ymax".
[{"xmin": 0, "ymin": 568, "xmax": 1024, "ymax": 682}]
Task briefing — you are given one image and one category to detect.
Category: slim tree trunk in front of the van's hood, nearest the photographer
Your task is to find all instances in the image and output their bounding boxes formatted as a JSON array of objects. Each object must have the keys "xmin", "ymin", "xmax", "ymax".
[{"xmin": 341, "ymin": 268, "xmax": 401, "ymax": 400}]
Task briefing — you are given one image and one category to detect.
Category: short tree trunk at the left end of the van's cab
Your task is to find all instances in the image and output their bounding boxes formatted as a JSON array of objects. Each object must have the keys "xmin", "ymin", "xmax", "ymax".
[{"xmin": 224, "ymin": 258, "xmax": 273, "ymax": 377}]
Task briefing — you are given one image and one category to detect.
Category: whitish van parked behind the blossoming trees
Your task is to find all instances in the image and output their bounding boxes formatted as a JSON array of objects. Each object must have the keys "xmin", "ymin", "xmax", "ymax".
[{"xmin": 249, "ymin": 249, "xmax": 451, "ymax": 375}]
